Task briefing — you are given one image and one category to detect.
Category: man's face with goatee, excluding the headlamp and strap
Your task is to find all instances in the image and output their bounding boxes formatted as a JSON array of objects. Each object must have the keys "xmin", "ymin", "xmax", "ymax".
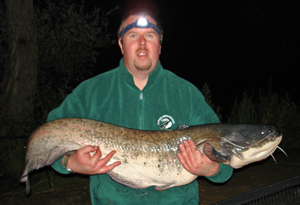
[{"xmin": 119, "ymin": 15, "xmax": 161, "ymax": 74}]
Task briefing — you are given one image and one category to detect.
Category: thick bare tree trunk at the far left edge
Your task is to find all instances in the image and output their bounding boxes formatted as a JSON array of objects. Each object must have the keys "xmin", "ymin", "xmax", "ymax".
[{"xmin": 1, "ymin": 0, "xmax": 38, "ymax": 135}]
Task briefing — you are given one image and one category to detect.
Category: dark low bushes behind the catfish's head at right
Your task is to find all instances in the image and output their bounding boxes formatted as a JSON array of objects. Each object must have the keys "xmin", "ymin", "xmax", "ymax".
[{"xmin": 228, "ymin": 91, "xmax": 300, "ymax": 149}]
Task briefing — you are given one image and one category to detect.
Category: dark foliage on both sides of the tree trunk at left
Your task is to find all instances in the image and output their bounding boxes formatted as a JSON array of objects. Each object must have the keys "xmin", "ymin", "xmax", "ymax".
[{"xmin": 0, "ymin": 0, "xmax": 118, "ymax": 136}]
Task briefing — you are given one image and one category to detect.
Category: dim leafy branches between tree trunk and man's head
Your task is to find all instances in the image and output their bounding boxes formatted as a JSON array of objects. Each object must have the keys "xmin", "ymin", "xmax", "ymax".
[{"xmin": 37, "ymin": 1, "xmax": 110, "ymax": 85}]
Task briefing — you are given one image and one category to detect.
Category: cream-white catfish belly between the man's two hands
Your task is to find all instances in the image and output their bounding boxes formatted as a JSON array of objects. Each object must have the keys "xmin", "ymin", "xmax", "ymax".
[{"xmin": 100, "ymin": 147, "xmax": 197, "ymax": 190}]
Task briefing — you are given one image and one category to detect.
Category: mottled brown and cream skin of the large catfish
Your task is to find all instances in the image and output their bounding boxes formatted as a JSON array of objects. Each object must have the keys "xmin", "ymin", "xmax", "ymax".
[{"xmin": 20, "ymin": 118, "xmax": 282, "ymax": 193}]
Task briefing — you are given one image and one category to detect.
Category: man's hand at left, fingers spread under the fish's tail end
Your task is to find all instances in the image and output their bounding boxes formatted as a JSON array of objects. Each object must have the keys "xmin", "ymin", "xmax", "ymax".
[{"xmin": 67, "ymin": 145, "xmax": 121, "ymax": 175}]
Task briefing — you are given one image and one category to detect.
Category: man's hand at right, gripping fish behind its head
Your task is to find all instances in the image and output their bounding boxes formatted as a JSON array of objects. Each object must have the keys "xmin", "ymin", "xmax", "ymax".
[{"xmin": 178, "ymin": 140, "xmax": 220, "ymax": 176}]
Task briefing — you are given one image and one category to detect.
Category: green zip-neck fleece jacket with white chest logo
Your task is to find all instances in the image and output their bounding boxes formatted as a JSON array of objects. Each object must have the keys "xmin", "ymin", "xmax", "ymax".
[{"xmin": 47, "ymin": 59, "xmax": 232, "ymax": 205}]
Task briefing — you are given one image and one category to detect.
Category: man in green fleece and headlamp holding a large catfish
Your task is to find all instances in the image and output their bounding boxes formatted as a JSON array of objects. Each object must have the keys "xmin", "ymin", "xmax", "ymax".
[{"xmin": 48, "ymin": 9, "xmax": 232, "ymax": 204}]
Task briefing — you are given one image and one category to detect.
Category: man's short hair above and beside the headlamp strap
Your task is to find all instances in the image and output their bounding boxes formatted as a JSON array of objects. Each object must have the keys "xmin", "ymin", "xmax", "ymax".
[{"xmin": 117, "ymin": 9, "xmax": 163, "ymax": 44}]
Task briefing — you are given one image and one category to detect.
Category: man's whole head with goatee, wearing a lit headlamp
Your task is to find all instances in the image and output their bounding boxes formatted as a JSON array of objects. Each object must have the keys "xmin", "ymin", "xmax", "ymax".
[{"xmin": 118, "ymin": 12, "xmax": 163, "ymax": 74}]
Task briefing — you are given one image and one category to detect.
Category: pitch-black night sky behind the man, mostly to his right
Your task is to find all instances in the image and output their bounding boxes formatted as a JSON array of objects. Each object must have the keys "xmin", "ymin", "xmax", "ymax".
[{"xmin": 86, "ymin": 0, "xmax": 300, "ymax": 115}]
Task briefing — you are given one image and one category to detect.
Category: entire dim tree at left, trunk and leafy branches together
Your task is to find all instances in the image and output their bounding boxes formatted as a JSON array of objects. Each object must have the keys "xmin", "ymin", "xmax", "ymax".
[{"xmin": 0, "ymin": 0, "xmax": 119, "ymax": 136}]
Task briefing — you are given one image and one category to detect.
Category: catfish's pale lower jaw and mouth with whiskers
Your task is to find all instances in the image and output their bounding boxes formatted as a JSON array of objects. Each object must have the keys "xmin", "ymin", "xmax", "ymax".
[{"xmin": 221, "ymin": 132, "xmax": 284, "ymax": 169}]
